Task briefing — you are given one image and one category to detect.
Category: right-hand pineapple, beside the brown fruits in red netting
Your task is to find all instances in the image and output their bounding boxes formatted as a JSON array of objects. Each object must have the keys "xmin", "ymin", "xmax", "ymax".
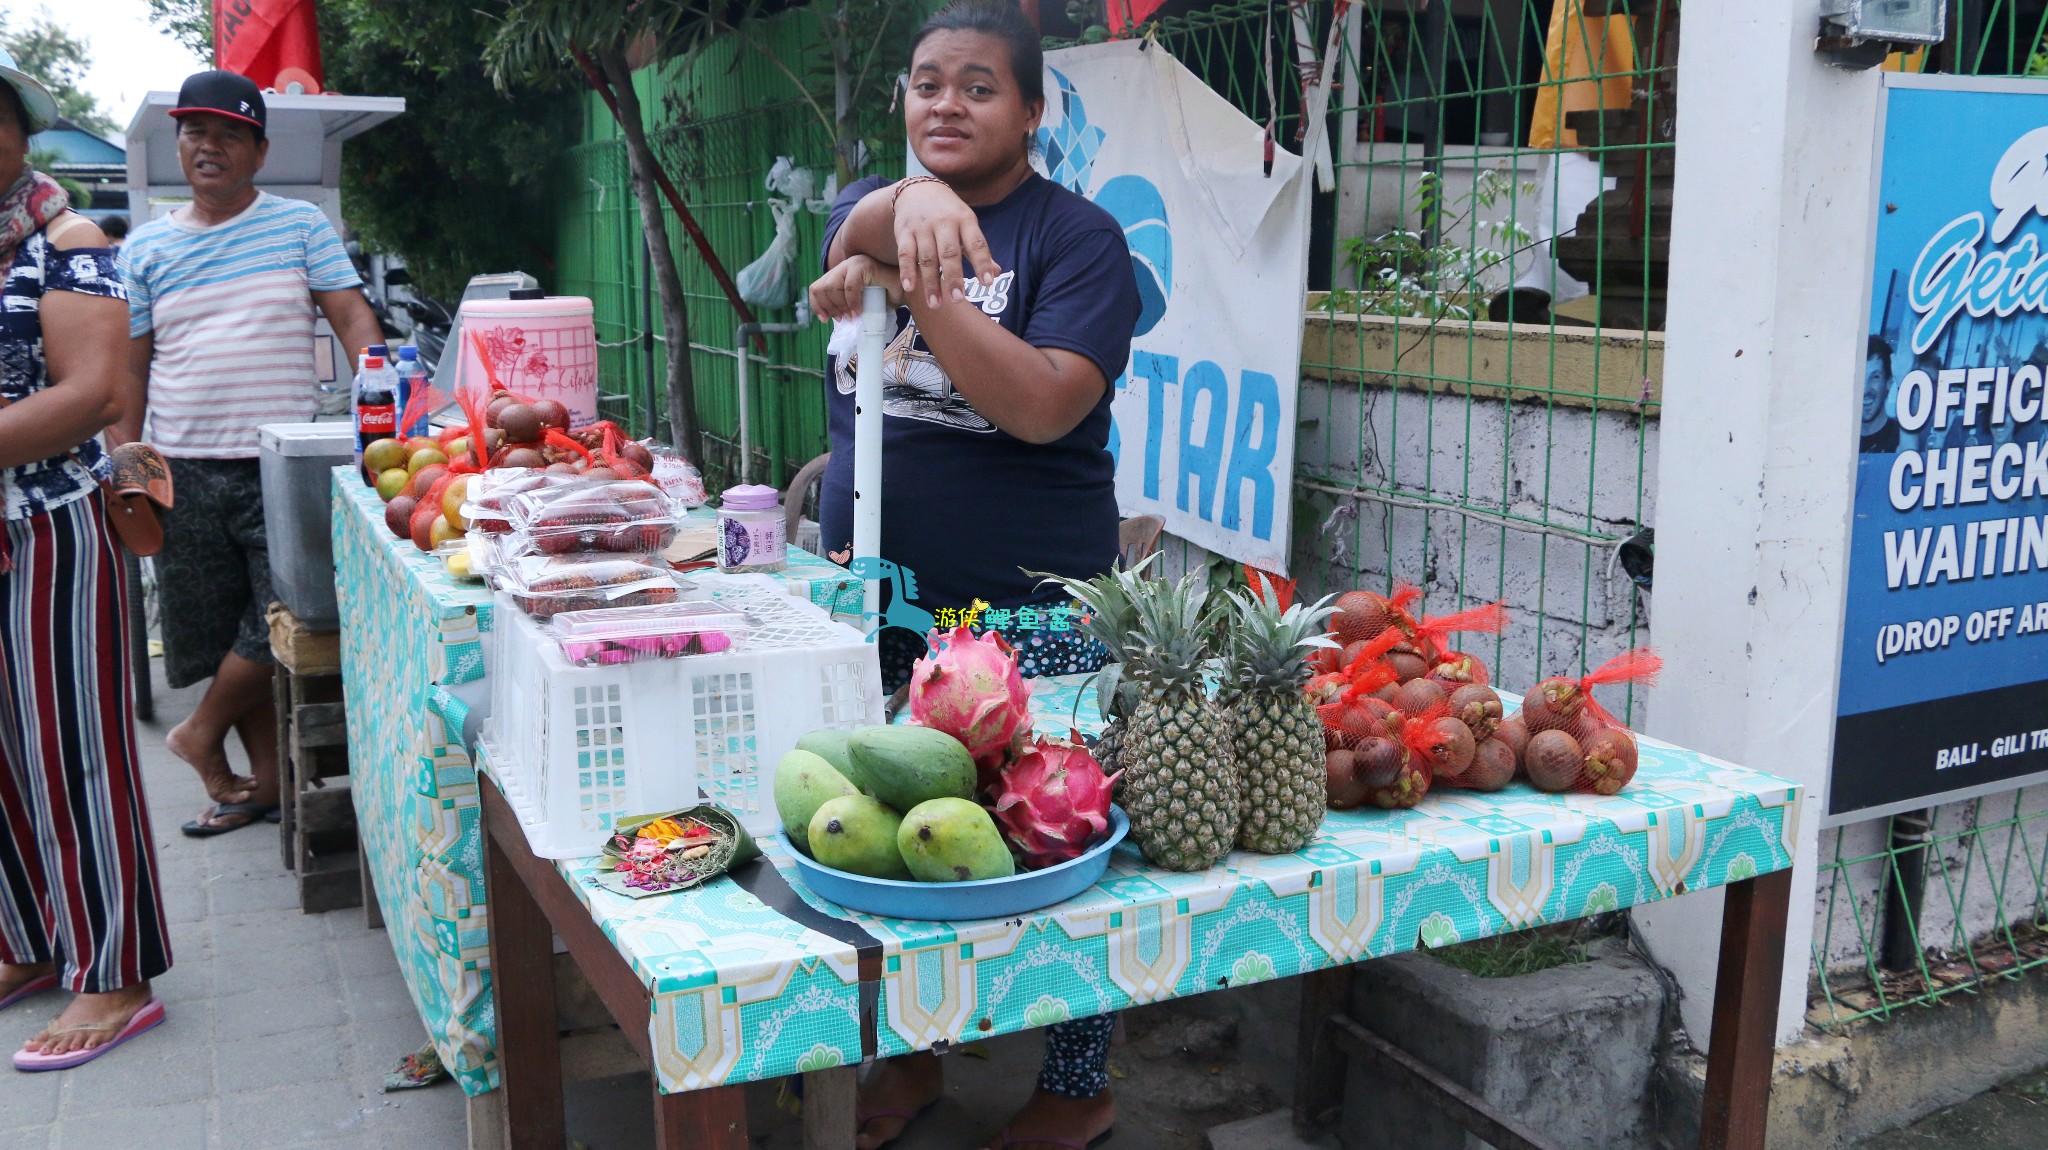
[{"xmin": 1223, "ymin": 591, "xmax": 1335, "ymax": 855}]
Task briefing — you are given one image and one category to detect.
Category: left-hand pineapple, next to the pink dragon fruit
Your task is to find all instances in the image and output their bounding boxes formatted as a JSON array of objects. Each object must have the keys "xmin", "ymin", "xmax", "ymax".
[{"xmin": 1118, "ymin": 569, "xmax": 1236, "ymax": 870}]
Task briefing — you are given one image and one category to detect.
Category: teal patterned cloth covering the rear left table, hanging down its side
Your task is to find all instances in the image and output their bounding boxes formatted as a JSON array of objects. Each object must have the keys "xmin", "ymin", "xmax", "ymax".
[{"xmin": 332, "ymin": 467, "xmax": 860, "ymax": 1095}]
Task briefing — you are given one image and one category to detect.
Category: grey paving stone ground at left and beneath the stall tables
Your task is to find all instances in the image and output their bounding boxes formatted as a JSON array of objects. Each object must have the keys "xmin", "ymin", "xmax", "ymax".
[{"xmin": 0, "ymin": 661, "xmax": 1274, "ymax": 1150}]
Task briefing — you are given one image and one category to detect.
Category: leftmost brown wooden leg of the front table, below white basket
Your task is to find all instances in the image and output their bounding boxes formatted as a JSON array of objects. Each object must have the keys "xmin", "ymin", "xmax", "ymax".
[{"xmin": 483, "ymin": 822, "xmax": 565, "ymax": 1150}]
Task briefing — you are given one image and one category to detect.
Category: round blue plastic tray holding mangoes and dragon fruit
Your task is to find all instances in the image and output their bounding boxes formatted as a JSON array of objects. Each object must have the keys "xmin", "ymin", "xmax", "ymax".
[{"xmin": 784, "ymin": 806, "xmax": 1130, "ymax": 921}]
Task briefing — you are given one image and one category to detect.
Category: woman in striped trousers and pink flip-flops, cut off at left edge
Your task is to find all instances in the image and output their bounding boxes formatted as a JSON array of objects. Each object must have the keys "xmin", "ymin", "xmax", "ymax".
[{"xmin": 0, "ymin": 53, "xmax": 170, "ymax": 1070}]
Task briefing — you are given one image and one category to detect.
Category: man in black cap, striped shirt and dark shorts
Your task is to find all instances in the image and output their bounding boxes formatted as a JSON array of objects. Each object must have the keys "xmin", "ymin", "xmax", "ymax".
[{"xmin": 111, "ymin": 72, "xmax": 381, "ymax": 835}]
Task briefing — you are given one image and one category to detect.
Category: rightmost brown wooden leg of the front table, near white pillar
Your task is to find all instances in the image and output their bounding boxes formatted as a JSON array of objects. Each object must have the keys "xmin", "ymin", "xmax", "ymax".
[{"xmin": 1700, "ymin": 870, "xmax": 1792, "ymax": 1150}]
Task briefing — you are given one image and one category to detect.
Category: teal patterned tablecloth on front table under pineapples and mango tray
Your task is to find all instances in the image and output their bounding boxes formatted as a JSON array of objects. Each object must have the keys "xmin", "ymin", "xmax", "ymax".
[{"xmin": 485, "ymin": 675, "xmax": 1802, "ymax": 1091}]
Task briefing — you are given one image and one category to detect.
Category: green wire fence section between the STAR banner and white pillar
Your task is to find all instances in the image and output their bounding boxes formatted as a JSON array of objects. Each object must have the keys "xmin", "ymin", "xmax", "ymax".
[{"xmin": 1296, "ymin": 0, "xmax": 1675, "ymax": 714}]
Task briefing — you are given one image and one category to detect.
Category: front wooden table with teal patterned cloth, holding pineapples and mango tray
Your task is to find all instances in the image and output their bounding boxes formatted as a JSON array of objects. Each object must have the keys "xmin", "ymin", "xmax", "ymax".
[{"xmin": 479, "ymin": 675, "xmax": 1800, "ymax": 1150}]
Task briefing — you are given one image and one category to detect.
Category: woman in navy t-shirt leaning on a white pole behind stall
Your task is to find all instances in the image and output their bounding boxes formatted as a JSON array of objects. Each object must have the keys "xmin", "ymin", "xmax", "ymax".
[{"xmin": 811, "ymin": 0, "xmax": 1141, "ymax": 1150}]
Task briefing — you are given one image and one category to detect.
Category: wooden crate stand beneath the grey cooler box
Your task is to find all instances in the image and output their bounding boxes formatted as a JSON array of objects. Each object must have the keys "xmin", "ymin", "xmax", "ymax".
[{"xmin": 270, "ymin": 604, "xmax": 365, "ymax": 915}]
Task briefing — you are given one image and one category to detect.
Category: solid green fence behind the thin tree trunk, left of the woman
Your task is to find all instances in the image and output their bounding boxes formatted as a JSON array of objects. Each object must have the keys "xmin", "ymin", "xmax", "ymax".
[{"xmin": 553, "ymin": 8, "xmax": 921, "ymax": 485}]
